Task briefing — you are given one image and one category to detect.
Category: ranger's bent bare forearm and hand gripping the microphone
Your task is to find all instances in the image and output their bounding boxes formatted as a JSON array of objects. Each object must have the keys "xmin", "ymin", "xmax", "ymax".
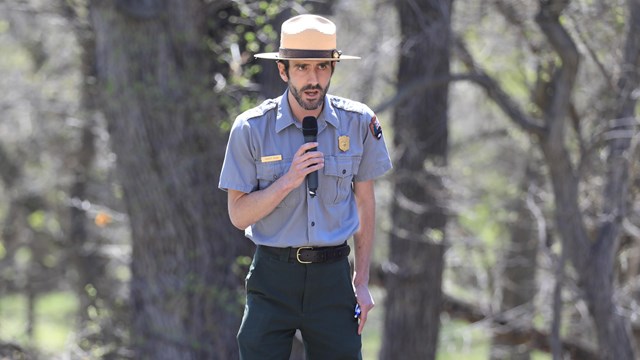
[{"xmin": 227, "ymin": 143, "xmax": 324, "ymax": 230}]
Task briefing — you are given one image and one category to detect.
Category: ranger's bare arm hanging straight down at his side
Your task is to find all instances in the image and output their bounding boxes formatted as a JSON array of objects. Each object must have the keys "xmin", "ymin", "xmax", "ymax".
[{"xmin": 353, "ymin": 180, "xmax": 376, "ymax": 334}]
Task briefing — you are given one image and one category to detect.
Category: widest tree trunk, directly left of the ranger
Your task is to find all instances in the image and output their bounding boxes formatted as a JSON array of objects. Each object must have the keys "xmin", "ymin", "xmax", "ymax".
[{"xmin": 89, "ymin": 0, "xmax": 246, "ymax": 360}]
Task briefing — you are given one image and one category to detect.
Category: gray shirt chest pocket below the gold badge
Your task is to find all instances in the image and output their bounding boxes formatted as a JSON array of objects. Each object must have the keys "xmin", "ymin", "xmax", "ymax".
[{"xmin": 318, "ymin": 156, "xmax": 360, "ymax": 205}]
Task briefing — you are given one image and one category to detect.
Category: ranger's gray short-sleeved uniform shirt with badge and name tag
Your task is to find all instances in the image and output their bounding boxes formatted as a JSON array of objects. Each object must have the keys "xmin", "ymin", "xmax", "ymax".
[{"xmin": 218, "ymin": 90, "xmax": 391, "ymax": 247}]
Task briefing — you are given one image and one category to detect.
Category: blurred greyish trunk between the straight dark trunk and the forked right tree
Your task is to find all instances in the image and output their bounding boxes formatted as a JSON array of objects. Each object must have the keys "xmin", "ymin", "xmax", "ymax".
[{"xmin": 490, "ymin": 165, "xmax": 539, "ymax": 360}]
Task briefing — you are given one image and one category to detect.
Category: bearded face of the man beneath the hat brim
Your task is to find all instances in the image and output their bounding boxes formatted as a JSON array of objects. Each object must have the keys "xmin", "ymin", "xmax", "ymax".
[{"xmin": 278, "ymin": 60, "xmax": 333, "ymax": 110}]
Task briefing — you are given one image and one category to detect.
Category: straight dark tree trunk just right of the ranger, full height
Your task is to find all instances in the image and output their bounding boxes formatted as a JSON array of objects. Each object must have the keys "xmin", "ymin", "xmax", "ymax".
[{"xmin": 380, "ymin": 0, "xmax": 452, "ymax": 359}]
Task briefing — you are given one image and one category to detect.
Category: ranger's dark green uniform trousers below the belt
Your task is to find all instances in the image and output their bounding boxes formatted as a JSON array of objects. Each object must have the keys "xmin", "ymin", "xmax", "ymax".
[{"xmin": 238, "ymin": 246, "xmax": 362, "ymax": 360}]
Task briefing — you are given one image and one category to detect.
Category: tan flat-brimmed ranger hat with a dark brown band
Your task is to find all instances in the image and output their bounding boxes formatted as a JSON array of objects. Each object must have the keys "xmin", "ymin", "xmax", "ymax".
[{"xmin": 255, "ymin": 15, "xmax": 360, "ymax": 61}]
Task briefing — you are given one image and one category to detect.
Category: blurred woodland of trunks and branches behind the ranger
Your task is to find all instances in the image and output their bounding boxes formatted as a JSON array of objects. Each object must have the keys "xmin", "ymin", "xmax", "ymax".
[{"xmin": 0, "ymin": 0, "xmax": 640, "ymax": 360}]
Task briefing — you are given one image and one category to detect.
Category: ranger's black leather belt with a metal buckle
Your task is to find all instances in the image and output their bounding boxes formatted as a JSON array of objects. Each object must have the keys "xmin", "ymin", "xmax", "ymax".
[{"xmin": 258, "ymin": 243, "xmax": 351, "ymax": 264}]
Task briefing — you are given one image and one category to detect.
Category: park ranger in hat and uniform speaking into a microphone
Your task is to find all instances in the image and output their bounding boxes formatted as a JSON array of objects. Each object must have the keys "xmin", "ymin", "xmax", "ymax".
[{"xmin": 219, "ymin": 15, "xmax": 391, "ymax": 360}]
